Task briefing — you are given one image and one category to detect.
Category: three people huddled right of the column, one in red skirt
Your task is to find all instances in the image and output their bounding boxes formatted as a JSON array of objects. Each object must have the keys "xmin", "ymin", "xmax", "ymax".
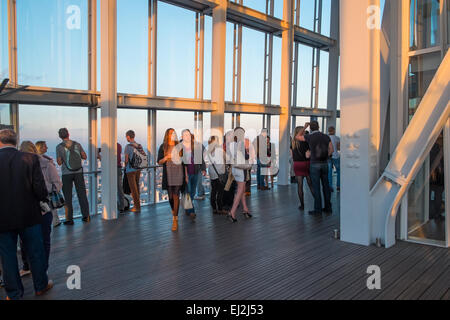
[{"xmin": 291, "ymin": 121, "xmax": 340, "ymax": 215}]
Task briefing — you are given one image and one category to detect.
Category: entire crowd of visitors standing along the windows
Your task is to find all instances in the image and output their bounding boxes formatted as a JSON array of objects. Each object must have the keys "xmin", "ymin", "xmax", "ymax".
[{"xmin": 0, "ymin": 121, "xmax": 340, "ymax": 299}]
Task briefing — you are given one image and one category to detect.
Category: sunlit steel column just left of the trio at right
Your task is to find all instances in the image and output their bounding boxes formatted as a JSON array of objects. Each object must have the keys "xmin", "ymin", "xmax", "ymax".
[{"xmin": 278, "ymin": 0, "xmax": 294, "ymax": 186}]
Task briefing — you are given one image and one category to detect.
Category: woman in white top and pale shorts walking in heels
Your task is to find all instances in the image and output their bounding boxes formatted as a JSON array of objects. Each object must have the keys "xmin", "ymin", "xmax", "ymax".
[{"xmin": 228, "ymin": 127, "xmax": 256, "ymax": 222}]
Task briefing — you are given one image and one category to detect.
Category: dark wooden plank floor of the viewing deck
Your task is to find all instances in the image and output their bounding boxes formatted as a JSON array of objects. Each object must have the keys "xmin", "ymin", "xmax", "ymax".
[{"xmin": 0, "ymin": 186, "xmax": 450, "ymax": 300}]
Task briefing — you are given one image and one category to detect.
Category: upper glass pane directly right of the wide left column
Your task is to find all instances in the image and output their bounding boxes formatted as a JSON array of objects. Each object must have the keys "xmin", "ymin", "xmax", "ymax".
[{"xmin": 117, "ymin": 0, "xmax": 148, "ymax": 95}]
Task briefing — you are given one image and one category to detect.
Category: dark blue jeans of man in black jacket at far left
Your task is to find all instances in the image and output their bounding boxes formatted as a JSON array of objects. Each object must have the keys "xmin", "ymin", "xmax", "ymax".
[{"xmin": 0, "ymin": 224, "xmax": 48, "ymax": 300}]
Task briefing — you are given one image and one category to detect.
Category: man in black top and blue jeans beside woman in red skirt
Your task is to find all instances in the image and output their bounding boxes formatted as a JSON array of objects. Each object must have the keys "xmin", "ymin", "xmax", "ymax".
[{"xmin": 299, "ymin": 121, "xmax": 334, "ymax": 215}]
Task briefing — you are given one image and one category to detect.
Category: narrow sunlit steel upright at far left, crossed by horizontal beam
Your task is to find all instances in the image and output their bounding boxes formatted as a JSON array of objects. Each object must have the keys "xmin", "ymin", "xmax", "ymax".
[{"xmin": 8, "ymin": 0, "xmax": 20, "ymax": 141}]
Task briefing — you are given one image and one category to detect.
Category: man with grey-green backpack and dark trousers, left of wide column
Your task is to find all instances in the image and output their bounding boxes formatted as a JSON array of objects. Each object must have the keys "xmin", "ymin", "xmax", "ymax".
[{"xmin": 56, "ymin": 128, "xmax": 91, "ymax": 225}]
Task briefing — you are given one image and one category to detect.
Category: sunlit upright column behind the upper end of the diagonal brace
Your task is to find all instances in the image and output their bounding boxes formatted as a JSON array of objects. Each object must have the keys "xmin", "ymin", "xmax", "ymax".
[{"xmin": 389, "ymin": 0, "xmax": 409, "ymax": 155}]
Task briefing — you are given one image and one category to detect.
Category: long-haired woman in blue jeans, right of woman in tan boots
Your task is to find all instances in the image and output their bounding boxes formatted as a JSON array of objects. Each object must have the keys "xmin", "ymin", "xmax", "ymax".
[{"xmin": 181, "ymin": 129, "xmax": 206, "ymax": 220}]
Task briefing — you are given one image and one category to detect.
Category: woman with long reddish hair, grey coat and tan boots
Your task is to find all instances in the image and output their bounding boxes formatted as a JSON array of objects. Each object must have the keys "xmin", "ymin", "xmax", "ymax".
[{"xmin": 158, "ymin": 128, "xmax": 185, "ymax": 231}]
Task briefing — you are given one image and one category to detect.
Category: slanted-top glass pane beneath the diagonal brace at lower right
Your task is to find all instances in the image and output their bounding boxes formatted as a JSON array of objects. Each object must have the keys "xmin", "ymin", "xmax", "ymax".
[{"xmin": 408, "ymin": 133, "xmax": 446, "ymax": 242}]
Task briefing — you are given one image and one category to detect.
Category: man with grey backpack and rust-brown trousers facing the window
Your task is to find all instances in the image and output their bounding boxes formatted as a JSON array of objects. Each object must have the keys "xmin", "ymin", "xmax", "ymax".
[{"xmin": 124, "ymin": 130, "xmax": 148, "ymax": 213}]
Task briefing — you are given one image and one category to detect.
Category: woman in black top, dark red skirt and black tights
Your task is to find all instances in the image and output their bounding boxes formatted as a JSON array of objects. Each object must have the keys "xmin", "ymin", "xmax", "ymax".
[{"xmin": 291, "ymin": 127, "xmax": 313, "ymax": 211}]
